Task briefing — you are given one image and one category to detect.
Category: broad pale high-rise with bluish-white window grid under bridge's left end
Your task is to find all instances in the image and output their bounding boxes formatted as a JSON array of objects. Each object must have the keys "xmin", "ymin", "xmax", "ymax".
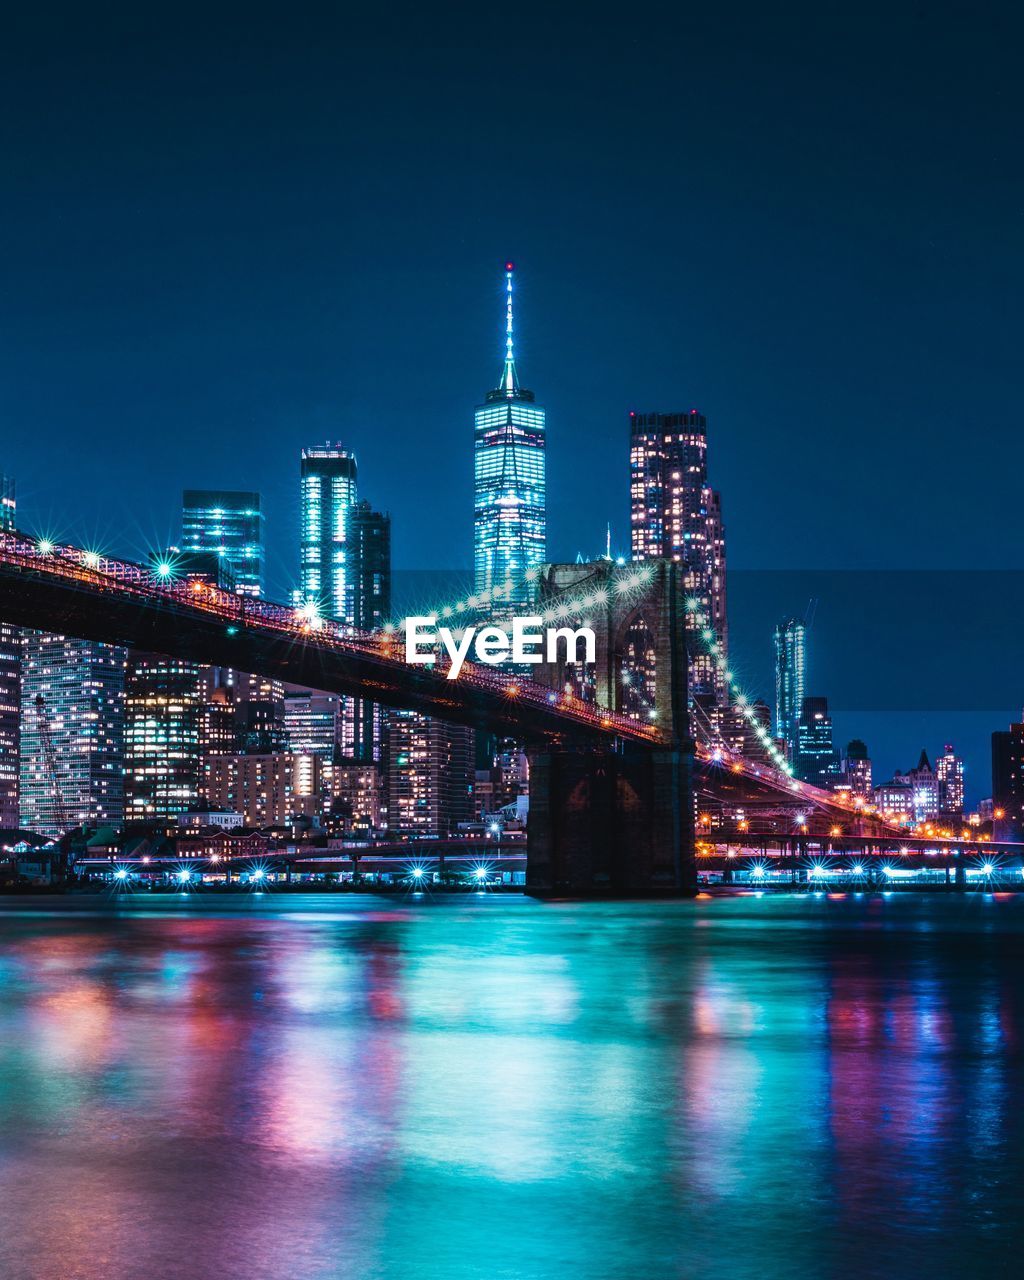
[{"xmin": 20, "ymin": 631, "xmax": 125, "ymax": 836}]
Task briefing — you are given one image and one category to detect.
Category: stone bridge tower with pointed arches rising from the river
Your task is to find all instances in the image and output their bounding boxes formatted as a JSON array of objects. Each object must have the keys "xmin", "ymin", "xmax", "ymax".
[{"xmin": 526, "ymin": 561, "xmax": 696, "ymax": 897}]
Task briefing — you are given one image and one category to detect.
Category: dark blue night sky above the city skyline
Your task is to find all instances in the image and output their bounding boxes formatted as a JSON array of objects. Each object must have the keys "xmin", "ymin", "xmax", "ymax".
[{"xmin": 0, "ymin": 4, "xmax": 1024, "ymax": 799}]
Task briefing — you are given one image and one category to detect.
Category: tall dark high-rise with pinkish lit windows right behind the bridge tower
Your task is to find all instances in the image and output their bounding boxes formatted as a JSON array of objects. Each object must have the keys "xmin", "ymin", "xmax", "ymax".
[{"xmin": 630, "ymin": 410, "xmax": 728, "ymax": 732}]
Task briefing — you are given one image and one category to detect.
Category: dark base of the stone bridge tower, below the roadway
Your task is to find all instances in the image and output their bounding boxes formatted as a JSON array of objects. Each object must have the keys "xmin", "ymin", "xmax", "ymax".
[{"xmin": 526, "ymin": 744, "xmax": 696, "ymax": 897}]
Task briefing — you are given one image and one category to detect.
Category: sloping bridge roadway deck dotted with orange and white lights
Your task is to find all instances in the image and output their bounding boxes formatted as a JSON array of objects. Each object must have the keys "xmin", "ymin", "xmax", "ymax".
[{"xmin": 0, "ymin": 530, "xmax": 896, "ymax": 835}]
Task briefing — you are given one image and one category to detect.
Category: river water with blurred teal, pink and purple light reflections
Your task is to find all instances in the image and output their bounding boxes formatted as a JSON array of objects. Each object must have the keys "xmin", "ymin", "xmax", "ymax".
[{"xmin": 0, "ymin": 895, "xmax": 1024, "ymax": 1280}]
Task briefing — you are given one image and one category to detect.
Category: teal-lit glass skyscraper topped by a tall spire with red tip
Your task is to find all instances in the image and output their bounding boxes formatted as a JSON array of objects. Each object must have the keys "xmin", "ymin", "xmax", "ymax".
[{"xmin": 474, "ymin": 262, "xmax": 547, "ymax": 614}]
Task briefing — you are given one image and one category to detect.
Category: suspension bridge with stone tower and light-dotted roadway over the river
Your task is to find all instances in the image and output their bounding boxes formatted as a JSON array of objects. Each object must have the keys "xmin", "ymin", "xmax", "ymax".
[{"xmin": 0, "ymin": 531, "xmax": 908, "ymax": 896}]
